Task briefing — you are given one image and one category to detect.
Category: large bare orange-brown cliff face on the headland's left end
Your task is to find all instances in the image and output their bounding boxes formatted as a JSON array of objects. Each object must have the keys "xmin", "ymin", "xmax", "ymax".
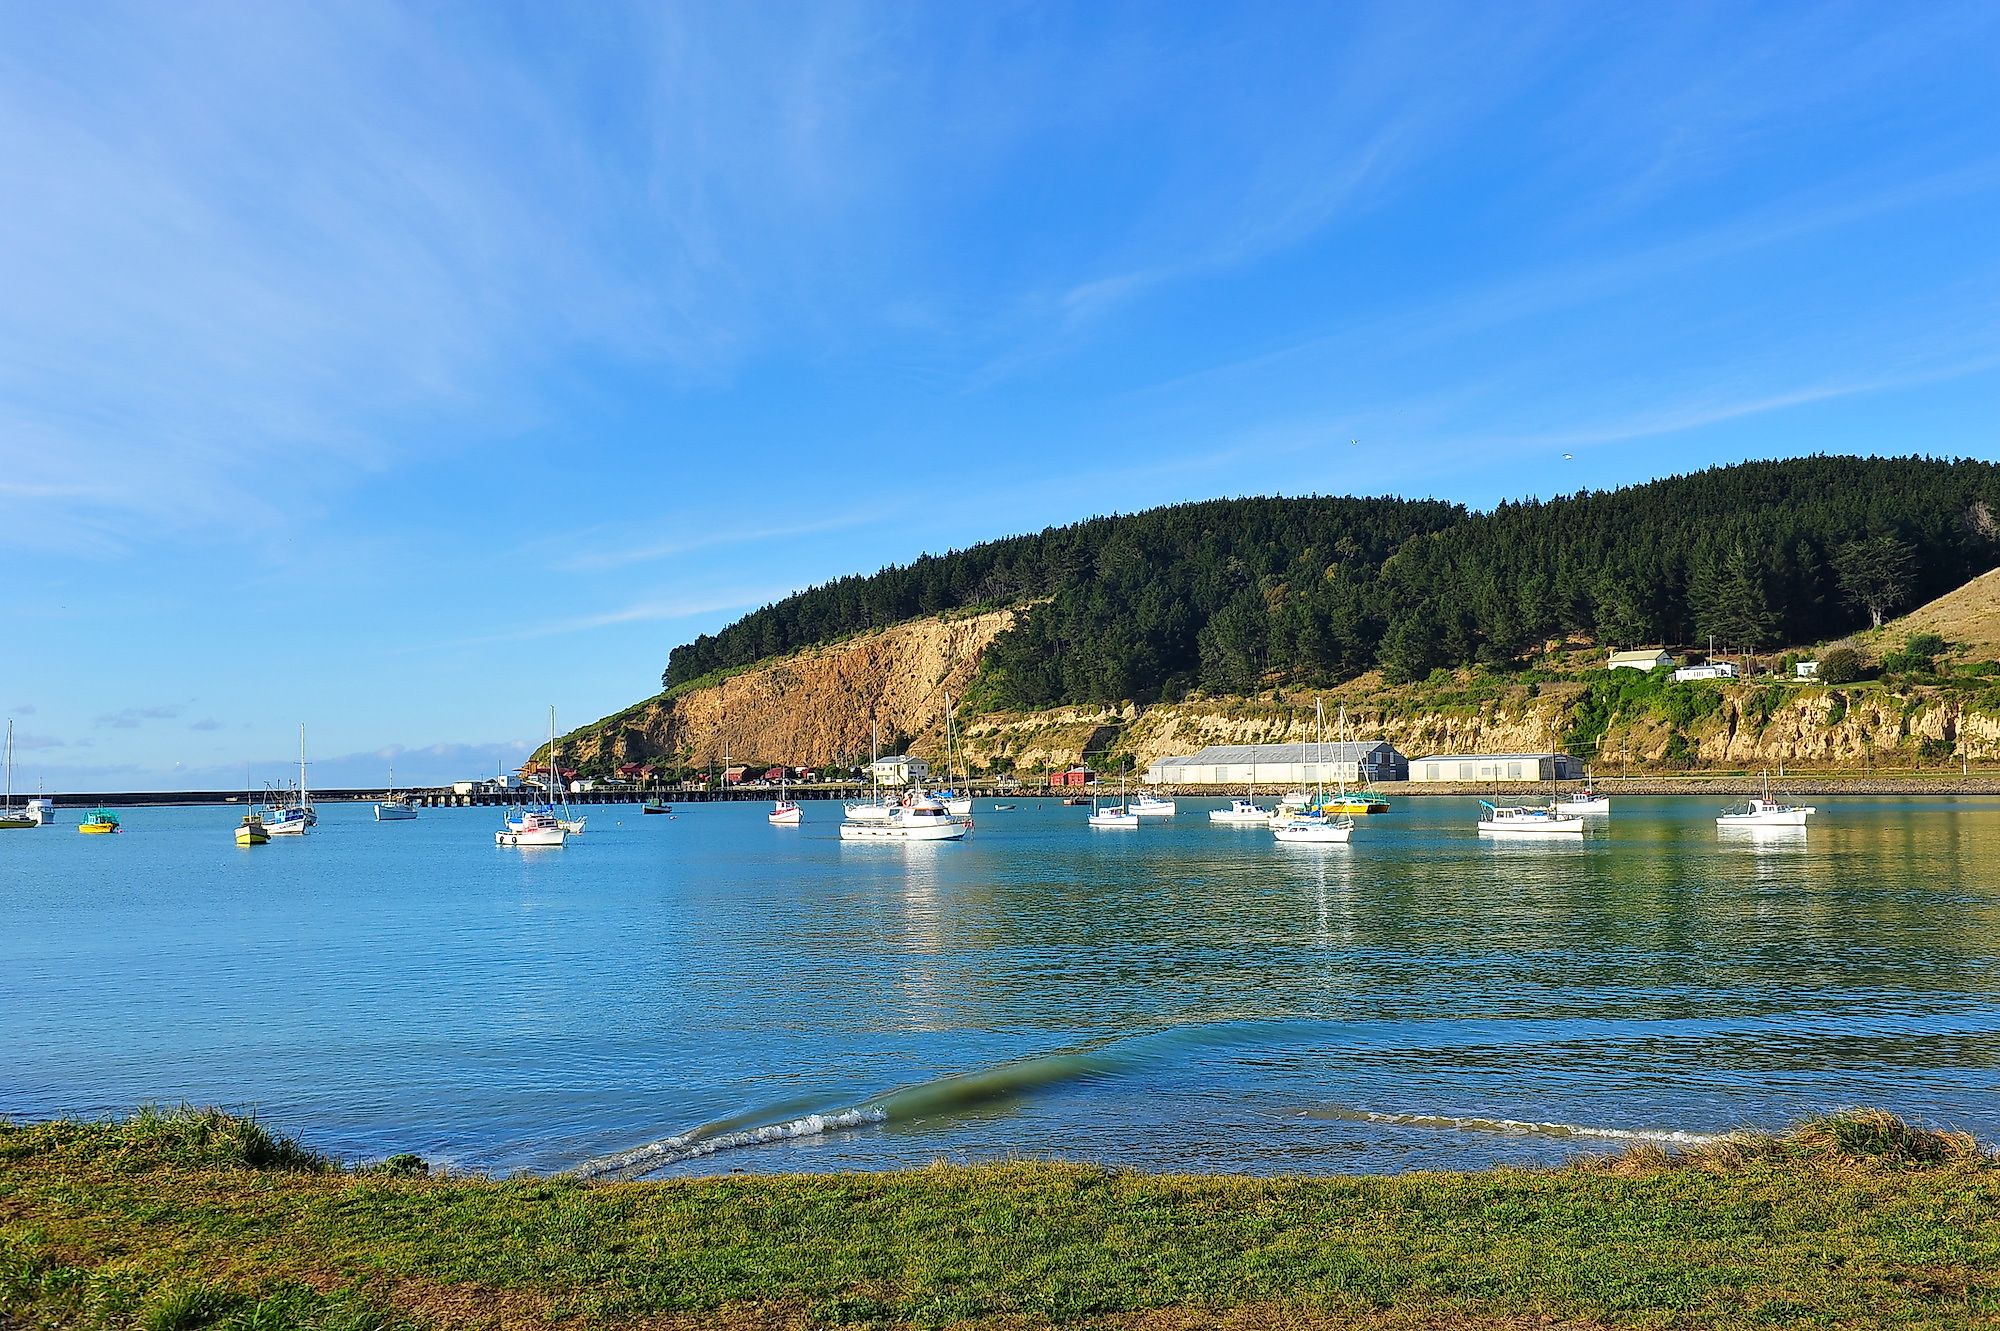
[{"xmin": 562, "ymin": 610, "xmax": 1014, "ymax": 767}]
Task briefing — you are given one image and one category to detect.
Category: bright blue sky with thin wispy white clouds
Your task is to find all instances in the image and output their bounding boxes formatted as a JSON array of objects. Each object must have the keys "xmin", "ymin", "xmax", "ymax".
[{"xmin": 0, "ymin": 2, "xmax": 2000, "ymax": 789}]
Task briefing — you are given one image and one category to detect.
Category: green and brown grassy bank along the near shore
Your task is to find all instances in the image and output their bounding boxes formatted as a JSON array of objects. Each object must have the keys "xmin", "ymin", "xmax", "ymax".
[{"xmin": 0, "ymin": 1111, "xmax": 2000, "ymax": 1331}]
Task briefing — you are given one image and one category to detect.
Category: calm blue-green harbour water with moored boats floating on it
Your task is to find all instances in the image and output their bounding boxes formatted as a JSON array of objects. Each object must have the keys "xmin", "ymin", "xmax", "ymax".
[{"xmin": 0, "ymin": 799, "xmax": 2000, "ymax": 1173}]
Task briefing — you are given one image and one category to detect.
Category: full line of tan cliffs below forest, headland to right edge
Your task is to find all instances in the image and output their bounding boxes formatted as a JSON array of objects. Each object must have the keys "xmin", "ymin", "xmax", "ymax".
[{"xmin": 564, "ymin": 610, "xmax": 2000, "ymax": 779}]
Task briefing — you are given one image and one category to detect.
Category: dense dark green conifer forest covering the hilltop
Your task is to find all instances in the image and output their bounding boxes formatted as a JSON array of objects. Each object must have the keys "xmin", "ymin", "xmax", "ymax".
[{"xmin": 664, "ymin": 458, "xmax": 2000, "ymax": 707}]
